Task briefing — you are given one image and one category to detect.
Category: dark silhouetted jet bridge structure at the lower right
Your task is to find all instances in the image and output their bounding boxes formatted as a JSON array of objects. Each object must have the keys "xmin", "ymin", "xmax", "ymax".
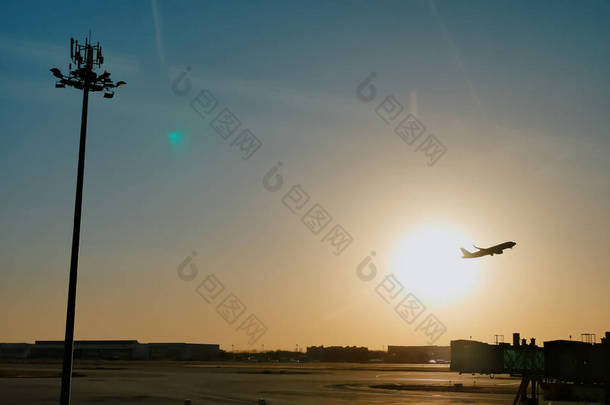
[{"xmin": 451, "ymin": 332, "xmax": 610, "ymax": 403}]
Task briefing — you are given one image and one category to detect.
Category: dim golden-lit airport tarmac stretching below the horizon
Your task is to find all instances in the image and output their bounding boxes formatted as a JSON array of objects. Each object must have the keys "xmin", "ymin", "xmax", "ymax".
[{"xmin": 0, "ymin": 361, "xmax": 519, "ymax": 405}]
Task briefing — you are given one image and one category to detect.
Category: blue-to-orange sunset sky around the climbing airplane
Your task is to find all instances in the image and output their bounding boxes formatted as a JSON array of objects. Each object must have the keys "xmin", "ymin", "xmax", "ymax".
[{"xmin": 0, "ymin": 1, "xmax": 610, "ymax": 350}]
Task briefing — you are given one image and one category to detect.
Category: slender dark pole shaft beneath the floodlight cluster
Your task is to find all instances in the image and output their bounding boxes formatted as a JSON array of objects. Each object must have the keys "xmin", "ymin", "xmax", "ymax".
[{"xmin": 60, "ymin": 79, "xmax": 89, "ymax": 405}]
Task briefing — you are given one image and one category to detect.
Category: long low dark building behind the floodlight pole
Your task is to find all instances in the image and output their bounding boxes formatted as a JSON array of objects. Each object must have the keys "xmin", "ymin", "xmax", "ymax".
[{"xmin": 0, "ymin": 340, "xmax": 223, "ymax": 361}]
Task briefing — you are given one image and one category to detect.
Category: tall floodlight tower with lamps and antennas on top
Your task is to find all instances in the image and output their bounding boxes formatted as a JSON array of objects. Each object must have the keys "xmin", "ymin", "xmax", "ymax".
[{"xmin": 51, "ymin": 35, "xmax": 126, "ymax": 405}]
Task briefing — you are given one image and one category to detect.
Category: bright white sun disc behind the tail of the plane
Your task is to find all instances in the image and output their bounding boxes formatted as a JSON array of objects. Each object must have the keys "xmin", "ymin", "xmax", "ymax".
[{"xmin": 392, "ymin": 225, "xmax": 480, "ymax": 302}]
